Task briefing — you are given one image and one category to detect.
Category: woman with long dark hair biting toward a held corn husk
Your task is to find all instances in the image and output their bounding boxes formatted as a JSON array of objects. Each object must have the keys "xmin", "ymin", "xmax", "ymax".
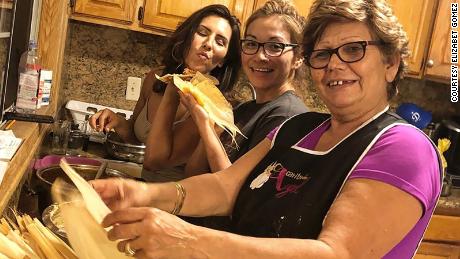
[{"xmin": 90, "ymin": 5, "xmax": 241, "ymax": 181}]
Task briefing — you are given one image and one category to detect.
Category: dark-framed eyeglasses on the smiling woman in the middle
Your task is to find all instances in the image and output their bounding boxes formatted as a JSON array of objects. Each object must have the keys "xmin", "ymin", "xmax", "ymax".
[{"xmin": 241, "ymin": 40, "xmax": 298, "ymax": 57}]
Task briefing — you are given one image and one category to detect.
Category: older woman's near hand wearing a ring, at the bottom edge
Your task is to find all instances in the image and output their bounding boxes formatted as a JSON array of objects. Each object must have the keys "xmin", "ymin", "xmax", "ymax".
[{"xmin": 102, "ymin": 207, "xmax": 206, "ymax": 258}]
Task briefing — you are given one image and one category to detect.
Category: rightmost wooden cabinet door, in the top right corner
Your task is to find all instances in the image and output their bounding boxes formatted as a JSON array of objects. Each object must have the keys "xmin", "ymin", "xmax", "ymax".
[{"xmin": 425, "ymin": 0, "xmax": 452, "ymax": 79}]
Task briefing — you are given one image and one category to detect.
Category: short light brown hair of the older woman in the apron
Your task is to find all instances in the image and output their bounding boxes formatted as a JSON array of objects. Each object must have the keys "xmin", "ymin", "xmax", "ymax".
[{"xmin": 302, "ymin": 0, "xmax": 409, "ymax": 99}]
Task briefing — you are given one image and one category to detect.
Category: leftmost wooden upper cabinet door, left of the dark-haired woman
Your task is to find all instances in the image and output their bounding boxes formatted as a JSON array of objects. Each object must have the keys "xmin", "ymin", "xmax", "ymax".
[{"xmin": 73, "ymin": 0, "xmax": 137, "ymax": 24}]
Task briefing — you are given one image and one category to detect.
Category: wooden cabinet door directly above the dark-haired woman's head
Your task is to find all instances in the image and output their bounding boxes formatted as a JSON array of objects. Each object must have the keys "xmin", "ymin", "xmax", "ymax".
[{"xmin": 142, "ymin": 0, "xmax": 253, "ymax": 31}]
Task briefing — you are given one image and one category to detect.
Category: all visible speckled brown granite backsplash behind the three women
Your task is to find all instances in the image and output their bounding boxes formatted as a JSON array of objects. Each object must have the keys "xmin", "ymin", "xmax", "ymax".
[{"xmin": 61, "ymin": 21, "xmax": 460, "ymax": 120}]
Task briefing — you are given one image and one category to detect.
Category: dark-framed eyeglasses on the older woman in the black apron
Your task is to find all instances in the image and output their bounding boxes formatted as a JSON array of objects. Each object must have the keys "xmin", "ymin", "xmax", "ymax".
[{"xmin": 305, "ymin": 41, "xmax": 384, "ymax": 69}]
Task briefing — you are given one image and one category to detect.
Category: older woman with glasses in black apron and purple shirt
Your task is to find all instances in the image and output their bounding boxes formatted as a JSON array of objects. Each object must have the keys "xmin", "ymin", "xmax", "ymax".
[{"xmin": 90, "ymin": 0, "xmax": 442, "ymax": 259}]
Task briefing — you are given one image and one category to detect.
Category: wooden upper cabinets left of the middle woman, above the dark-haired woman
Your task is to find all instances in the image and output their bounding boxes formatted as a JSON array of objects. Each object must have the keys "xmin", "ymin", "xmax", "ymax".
[{"xmin": 71, "ymin": 0, "xmax": 254, "ymax": 35}]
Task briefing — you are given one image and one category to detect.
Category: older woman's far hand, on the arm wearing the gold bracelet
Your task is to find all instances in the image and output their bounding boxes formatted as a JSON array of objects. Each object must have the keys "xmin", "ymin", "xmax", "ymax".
[{"xmin": 90, "ymin": 178, "xmax": 150, "ymax": 210}]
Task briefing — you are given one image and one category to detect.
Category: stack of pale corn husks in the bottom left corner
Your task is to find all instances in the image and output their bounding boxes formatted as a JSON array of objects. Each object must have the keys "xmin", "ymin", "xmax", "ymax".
[{"xmin": 0, "ymin": 212, "xmax": 78, "ymax": 259}]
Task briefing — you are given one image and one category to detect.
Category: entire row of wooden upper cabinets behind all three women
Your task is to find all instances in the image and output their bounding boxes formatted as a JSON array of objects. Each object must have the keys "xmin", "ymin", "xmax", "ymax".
[{"xmin": 71, "ymin": 0, "xmax": 450, "ymax": 80}]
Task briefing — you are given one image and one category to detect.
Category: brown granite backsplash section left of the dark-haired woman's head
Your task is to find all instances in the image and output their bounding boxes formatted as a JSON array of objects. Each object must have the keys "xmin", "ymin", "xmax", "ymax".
[{"xmin": 62, "ymin": 21, "xmax": 167, "ymax": 110}]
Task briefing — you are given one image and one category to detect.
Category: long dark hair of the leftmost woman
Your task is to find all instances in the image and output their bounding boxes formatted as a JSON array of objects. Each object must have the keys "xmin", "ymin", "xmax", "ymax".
[{"xmin": 153, "ymin": 4, "xmax": 241, "ymax": 93}]
